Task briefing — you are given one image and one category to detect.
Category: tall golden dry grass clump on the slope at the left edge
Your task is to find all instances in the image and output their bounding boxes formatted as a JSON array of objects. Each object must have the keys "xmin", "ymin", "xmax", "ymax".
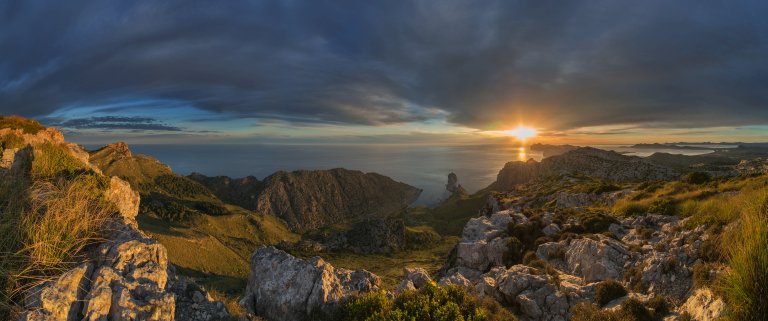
[{"xmin": 0, "ymin": 174, "xmax": 116, "ymax": 316}]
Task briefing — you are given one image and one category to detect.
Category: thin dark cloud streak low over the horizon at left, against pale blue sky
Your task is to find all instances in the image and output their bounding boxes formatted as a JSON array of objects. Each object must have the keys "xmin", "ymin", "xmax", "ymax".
[{"xmin": 43, "ymin": 116, "xmax": 182, "ymax": 131}]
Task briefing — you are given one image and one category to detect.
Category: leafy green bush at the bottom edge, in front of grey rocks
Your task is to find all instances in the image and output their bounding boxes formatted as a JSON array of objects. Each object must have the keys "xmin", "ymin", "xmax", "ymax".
[{"xmin": 340, "ymin": 284, "xmax": 517, "ymax": 321}]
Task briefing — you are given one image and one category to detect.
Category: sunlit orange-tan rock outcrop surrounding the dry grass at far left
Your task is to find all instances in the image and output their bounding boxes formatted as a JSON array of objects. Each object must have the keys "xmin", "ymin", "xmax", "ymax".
[{"xmin": 6, "ymin": 122, "xmax": 228, "ymax": 321}]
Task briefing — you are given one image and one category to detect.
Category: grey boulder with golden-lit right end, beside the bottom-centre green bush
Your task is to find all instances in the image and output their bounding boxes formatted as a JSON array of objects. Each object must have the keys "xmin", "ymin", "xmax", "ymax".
[{"xmin": 240, "ymin": 246, "xmax": 381, "ymax": 321}]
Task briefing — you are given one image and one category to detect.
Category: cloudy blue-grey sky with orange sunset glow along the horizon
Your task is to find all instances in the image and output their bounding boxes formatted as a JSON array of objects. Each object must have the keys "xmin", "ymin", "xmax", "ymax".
[{"xmin": 0, "ymin": 0, "xmax": 768, "ymax": 144}]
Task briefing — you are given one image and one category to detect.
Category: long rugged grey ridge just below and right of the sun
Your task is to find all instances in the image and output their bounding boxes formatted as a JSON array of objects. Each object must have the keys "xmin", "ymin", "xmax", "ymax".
[{"xmin": 493, "ymin": 147, "xmax": 680, "ymax": 190}]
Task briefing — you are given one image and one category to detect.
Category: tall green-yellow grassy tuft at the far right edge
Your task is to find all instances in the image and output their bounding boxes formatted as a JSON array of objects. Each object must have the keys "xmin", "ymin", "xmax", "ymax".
[{"xmin": 719, "ymin": 193, "xmax": 768, "ymax": 320}]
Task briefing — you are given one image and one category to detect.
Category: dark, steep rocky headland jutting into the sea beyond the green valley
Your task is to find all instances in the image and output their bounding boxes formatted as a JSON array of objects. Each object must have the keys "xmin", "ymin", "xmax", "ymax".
[{"xmin": 189, "ymin": 168, "xmax": 421, "ymax": 232}]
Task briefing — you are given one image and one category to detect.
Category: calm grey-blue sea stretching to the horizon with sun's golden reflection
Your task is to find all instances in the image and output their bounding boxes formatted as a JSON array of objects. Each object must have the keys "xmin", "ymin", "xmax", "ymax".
[{"xmin": 93, "ymin": 144, "xmax": 717, "ymax": 205}]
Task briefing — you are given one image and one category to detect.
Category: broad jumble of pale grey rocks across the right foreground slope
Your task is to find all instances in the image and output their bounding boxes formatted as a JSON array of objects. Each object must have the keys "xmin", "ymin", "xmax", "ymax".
[{"xmin": 440, "ymin": 201, "xmax": 722, "ymax": 320}]
